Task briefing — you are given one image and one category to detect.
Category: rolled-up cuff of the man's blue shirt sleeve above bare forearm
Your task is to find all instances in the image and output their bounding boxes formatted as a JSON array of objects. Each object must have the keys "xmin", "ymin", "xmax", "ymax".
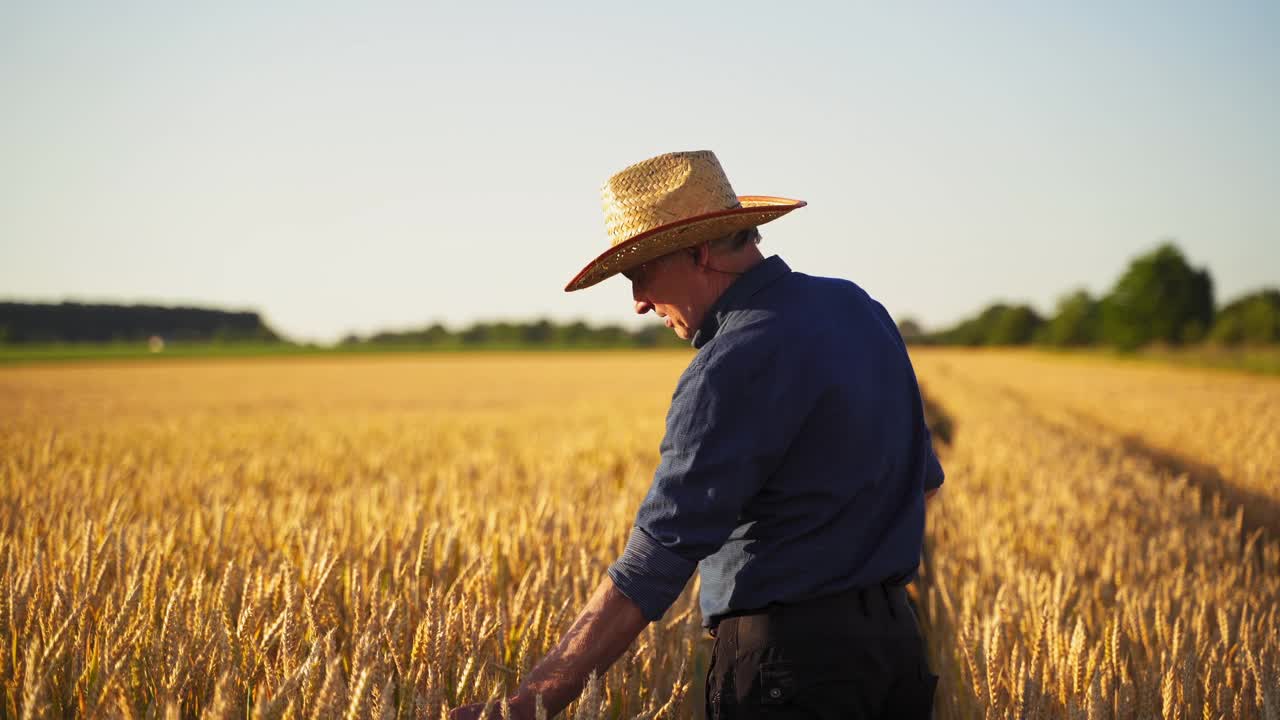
[{"xmin": 609, "ymin": 527, "xmax": 698, "ymax": 623}]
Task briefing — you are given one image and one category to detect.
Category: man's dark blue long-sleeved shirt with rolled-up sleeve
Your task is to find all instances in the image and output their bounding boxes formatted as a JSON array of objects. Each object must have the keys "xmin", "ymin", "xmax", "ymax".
[{"xmin": 609, "ymin": 256, "xmax": 943, "ymax": 626}]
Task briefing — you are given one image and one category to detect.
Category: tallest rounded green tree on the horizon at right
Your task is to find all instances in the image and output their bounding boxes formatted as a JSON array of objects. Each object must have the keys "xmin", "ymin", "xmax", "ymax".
[{"xmin": 1102, "ymin": 242, "xmax": 1213, "ymax": 350}]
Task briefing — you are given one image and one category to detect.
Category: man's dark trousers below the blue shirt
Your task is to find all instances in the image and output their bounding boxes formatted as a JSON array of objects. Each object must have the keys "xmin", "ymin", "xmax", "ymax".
[{"xmin": 707, "ymin": 585, "xmax": 938, "ymax": 720}]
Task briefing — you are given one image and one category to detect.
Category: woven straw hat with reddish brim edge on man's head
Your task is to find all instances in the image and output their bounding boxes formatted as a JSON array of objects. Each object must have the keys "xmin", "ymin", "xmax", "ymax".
[{"xmin": 564, "ymin": 150, "xmax": 805, "ymax": 292}]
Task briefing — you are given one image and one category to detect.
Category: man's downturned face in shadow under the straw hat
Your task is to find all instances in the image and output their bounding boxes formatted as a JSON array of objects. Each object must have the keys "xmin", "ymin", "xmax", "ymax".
[{"xmin": 622, "ymin": 249, "xmax": 707, "ymax": 340}]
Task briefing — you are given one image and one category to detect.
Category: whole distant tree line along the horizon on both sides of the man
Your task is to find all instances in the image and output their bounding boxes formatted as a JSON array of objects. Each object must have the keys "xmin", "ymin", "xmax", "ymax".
[{"xmin": 0, "ymin": 242, "xmax": 1280, "ymax": 350}]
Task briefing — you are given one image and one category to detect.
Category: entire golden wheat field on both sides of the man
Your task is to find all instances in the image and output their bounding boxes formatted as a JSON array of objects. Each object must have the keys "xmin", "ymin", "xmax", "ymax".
[{"xmin": 0, "ymin": 350, "xmax": 1280, "ymax": 720}]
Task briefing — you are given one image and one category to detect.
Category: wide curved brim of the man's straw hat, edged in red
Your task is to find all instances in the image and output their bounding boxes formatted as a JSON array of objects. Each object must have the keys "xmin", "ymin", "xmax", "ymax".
[{"xmin": 564, "ymin": 195, "xmax": 808, "ymax": 292}]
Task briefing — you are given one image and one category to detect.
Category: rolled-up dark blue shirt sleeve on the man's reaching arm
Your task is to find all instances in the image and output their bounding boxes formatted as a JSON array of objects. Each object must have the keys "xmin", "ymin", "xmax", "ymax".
[{"xmin": 609, "ymin": 345, "xmax": 799, "ymax": 620}]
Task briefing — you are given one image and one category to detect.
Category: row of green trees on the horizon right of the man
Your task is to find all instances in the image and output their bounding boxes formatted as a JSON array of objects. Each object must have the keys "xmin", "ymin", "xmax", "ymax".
[{"xmin": 916, "ymin": 242, "xmax": 1280, "ymax": 350}]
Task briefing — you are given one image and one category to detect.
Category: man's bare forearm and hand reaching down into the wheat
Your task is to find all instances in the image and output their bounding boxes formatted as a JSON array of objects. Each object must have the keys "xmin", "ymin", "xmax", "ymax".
[{"xmin": 449, "ymin": 578, "xmax": 649, "ymax": 720}]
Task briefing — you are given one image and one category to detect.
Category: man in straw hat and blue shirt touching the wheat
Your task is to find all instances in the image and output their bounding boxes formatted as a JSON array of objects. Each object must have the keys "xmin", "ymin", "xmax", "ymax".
[{"xmin": 453, "ymin": 151, "xmax": 943, "ymax": 719}]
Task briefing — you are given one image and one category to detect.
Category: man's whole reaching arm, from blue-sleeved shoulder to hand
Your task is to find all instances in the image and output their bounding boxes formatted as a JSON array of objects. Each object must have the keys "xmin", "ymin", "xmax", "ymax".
[{"xmin": 452, "ymin": 346, "xmax": 793, "ymax": 720}]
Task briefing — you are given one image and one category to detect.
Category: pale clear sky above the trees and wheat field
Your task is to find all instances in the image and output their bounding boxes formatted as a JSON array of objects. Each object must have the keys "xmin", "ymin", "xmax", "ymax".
[{"xmin": 0, "ymin": 0, "xmax": 1280, "ymax": 342}]
